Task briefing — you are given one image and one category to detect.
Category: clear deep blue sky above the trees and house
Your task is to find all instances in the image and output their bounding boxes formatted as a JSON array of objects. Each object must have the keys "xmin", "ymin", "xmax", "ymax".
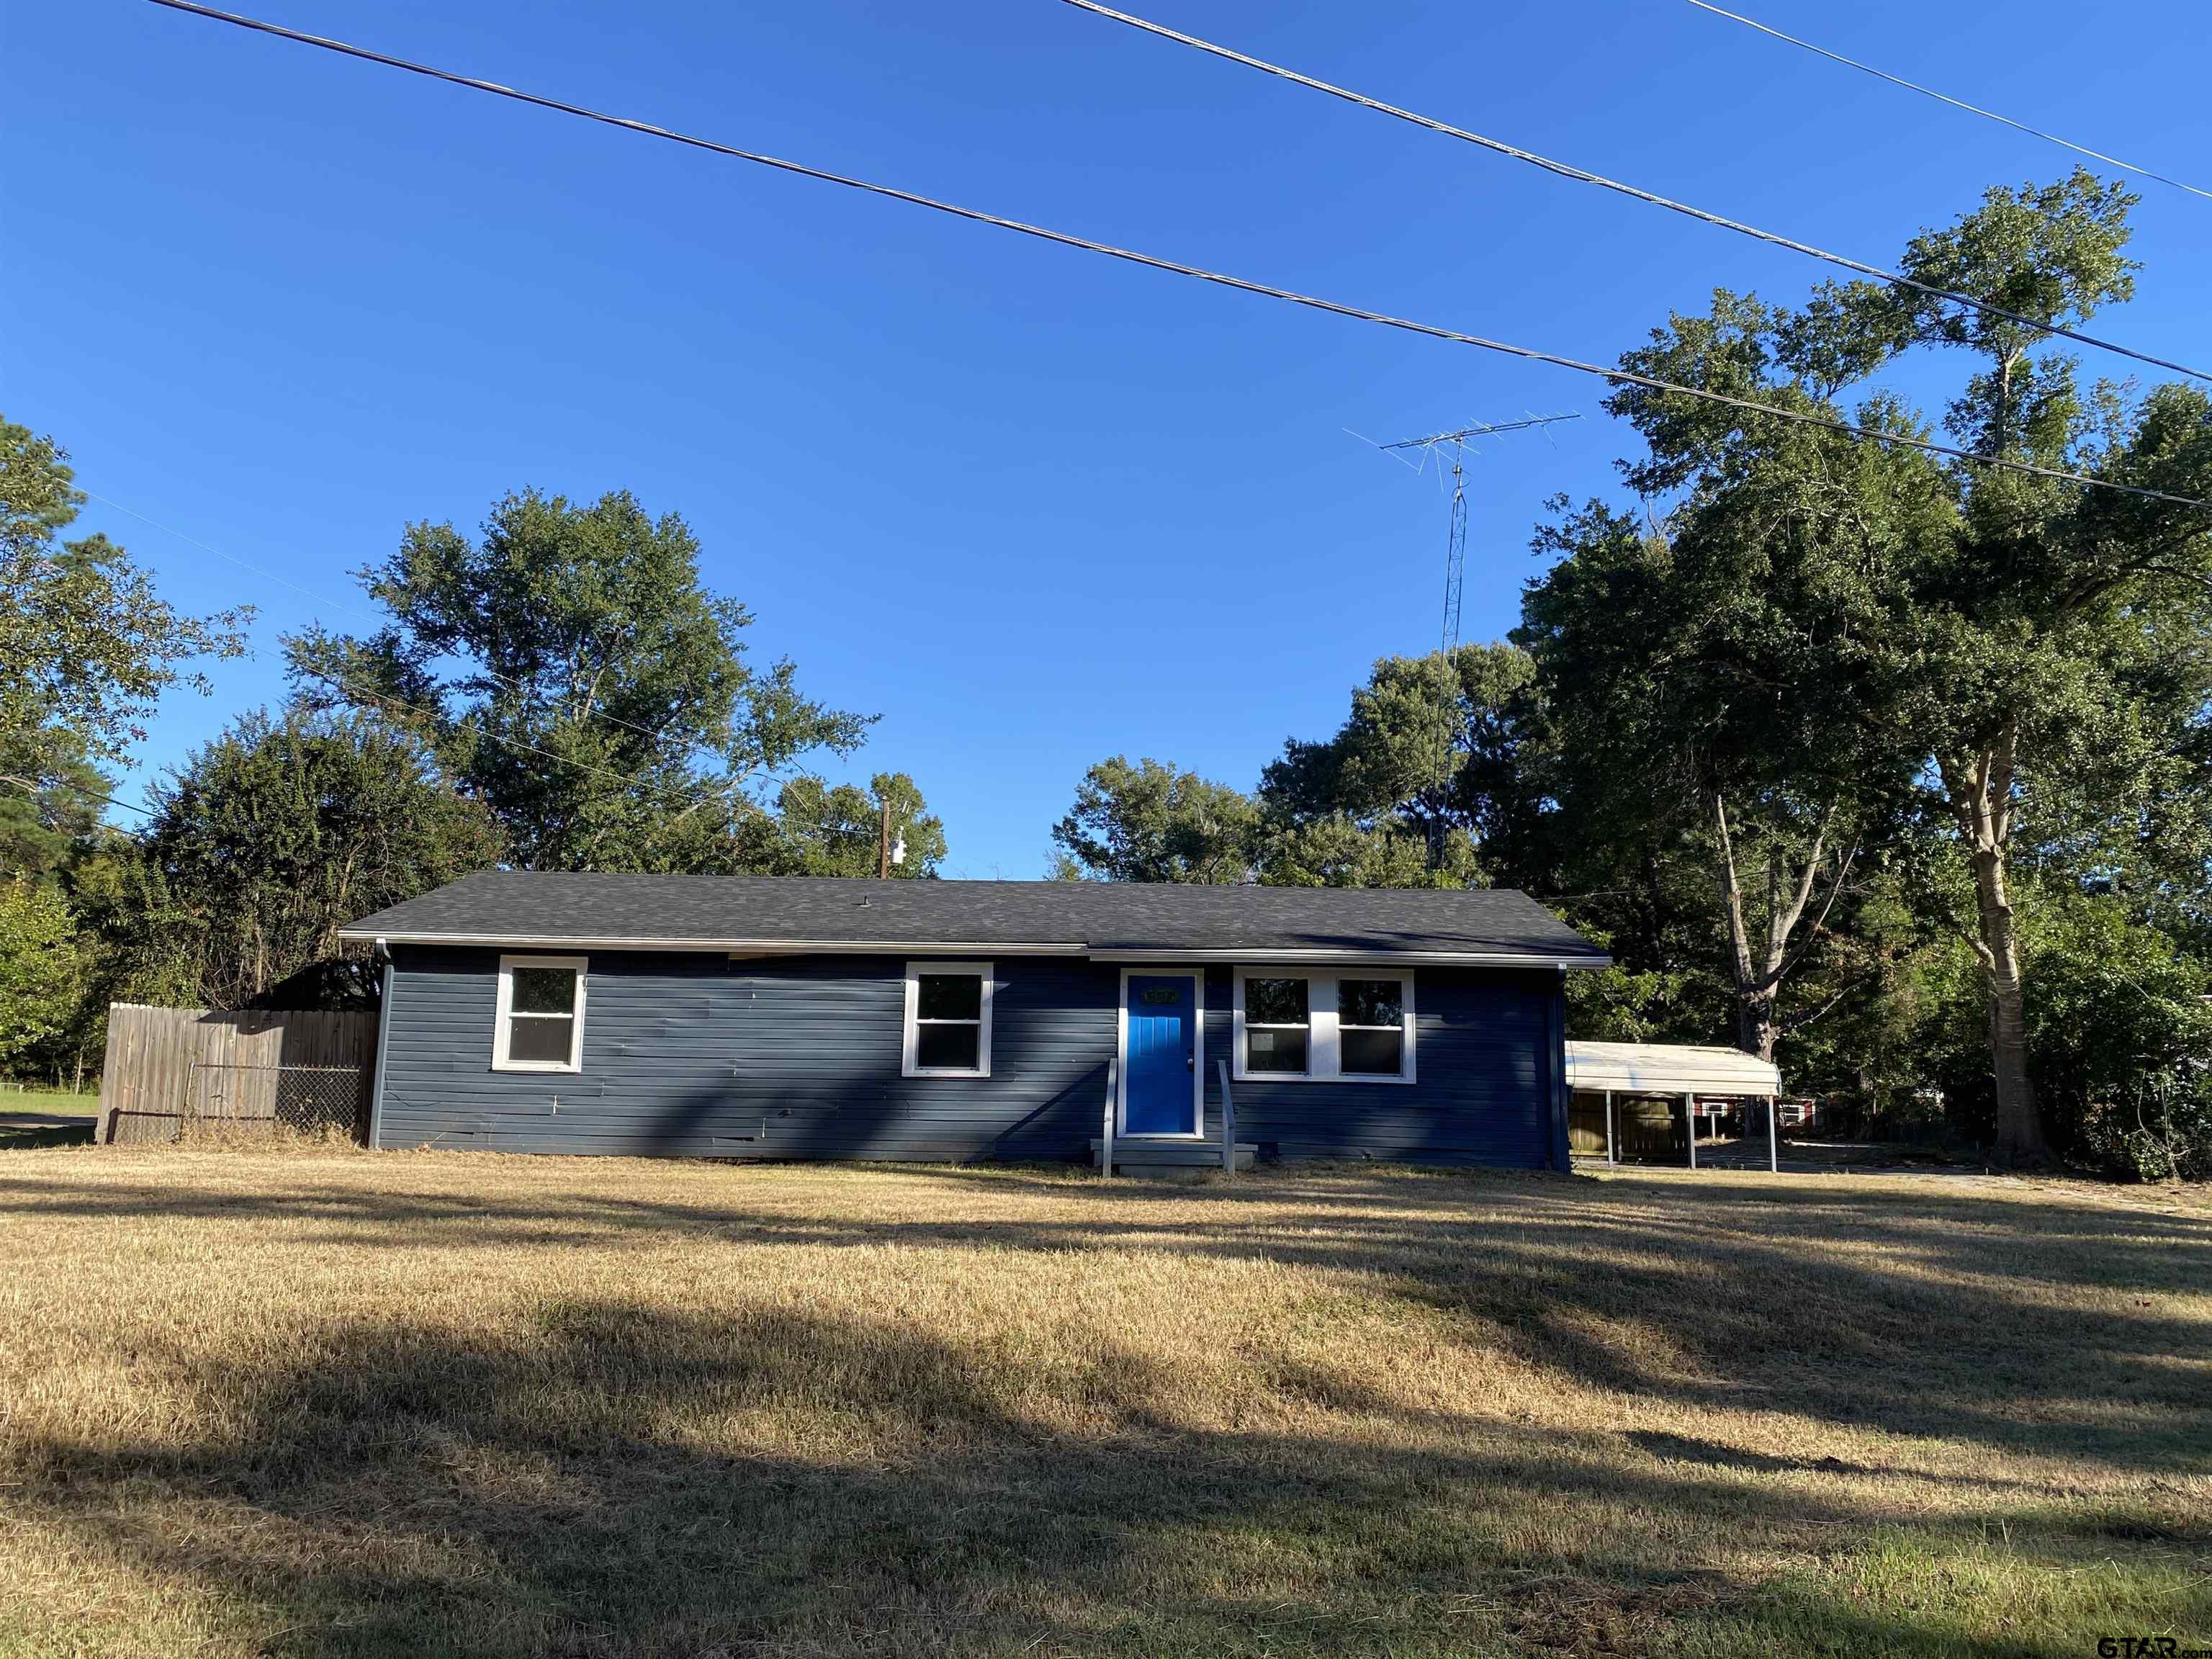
[{"xmin": 0, "ymin": 0, "xmax": 2212, "ymax": 876}]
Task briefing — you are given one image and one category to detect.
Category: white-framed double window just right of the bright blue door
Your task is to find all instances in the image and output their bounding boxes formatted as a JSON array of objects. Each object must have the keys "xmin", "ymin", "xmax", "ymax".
[{"xmin": 1232, "ymin": 966, "xmax": 1413, "ymax": 1084}]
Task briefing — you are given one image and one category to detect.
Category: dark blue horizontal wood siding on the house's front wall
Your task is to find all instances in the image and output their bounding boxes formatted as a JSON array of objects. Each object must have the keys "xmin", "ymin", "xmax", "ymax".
[{"xmin": 378, "ymin": 947, "xmax": 1564, "ymax": 1166}]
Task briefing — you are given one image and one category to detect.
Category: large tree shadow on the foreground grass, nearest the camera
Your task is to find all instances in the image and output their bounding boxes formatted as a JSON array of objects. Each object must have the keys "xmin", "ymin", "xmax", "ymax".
[{"xmin": 11, "ymin": 1298, "xmax": 2172, "ymax": 1659}]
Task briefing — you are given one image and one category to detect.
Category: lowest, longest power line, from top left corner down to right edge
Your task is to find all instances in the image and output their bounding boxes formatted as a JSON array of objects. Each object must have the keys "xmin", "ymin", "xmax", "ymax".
[{"xmin": 148, "ymin": 0, "xmax": 2212, "ymax": 509}]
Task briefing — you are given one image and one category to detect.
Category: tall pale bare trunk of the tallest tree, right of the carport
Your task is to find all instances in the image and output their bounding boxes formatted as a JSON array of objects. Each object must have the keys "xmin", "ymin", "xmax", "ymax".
[{"xmin": 1942, "ymin": 719, "xmax": 2051, "ymax": 1164}]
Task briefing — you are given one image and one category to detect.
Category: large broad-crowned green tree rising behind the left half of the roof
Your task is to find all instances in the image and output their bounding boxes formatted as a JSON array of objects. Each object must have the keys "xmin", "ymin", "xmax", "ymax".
[{"xmin": 285, "ymin": 491, "xmax": 871, "ymax": 871}]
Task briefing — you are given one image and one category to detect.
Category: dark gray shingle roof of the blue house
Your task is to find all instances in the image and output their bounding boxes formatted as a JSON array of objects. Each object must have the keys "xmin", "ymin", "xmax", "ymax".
[{"xmin": 345, "ymin": 869, "xmax": 1606, "ymax": 966}]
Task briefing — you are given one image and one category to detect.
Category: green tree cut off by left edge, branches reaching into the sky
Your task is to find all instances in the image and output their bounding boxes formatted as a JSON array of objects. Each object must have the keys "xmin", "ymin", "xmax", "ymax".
[{"xmin": 0, "ymin": 418, "xmax": 252, "ymax": 790}]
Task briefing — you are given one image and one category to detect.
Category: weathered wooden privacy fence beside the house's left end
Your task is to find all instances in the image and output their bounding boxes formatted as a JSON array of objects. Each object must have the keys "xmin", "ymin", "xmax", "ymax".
[{"xmin": 99, "ymin": 1002, "xmax": 376, "ymax": 1146}]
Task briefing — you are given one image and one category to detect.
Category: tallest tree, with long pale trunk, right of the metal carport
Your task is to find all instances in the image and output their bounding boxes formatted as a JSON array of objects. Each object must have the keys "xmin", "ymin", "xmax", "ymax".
[{"xmin": 1610, "ymin": 173, "xmax": 2212, "ymax": 1161}]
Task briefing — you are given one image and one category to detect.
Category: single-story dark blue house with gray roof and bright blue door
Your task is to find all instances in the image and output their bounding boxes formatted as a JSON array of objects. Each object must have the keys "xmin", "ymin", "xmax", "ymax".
[{"xmin": 343, "ymin": 871, "xmax": 1608, "ymax": 1168}]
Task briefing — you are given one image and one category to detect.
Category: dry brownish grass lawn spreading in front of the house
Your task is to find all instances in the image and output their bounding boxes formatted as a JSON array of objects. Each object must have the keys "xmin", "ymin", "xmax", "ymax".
[{"xmin": 0, "ymin": 1148, "xmax": 2212, "ymax": 1659}]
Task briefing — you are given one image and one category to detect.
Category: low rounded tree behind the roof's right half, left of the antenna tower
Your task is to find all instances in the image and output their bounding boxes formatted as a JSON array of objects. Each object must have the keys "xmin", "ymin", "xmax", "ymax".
[{"xmin": 1053, "ymin": 755, "xmax": 1261, "ymax": 885}]
